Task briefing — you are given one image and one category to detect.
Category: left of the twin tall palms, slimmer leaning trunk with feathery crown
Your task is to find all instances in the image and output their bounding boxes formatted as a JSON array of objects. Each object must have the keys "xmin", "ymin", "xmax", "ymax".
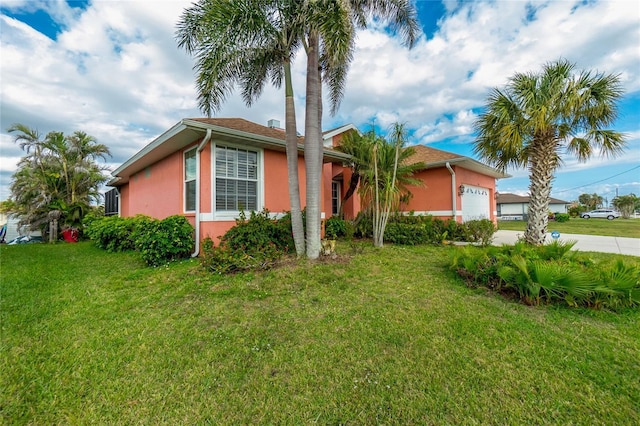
[{"xmin": 176, "ymin": 0, "xmax": 305, "ymax": 256}]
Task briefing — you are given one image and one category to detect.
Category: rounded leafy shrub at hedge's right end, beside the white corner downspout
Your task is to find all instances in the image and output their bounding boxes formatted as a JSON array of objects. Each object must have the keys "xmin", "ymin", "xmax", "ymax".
[{"xmin": 133, "ymin": 215, "xmax": 194, "ymax": 266}]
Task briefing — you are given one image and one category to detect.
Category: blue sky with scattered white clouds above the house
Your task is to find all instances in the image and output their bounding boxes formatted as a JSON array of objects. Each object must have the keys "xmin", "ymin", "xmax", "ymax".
[{"xmin": 0, "ymin": 0, "xmax": 640, "ymax": 205}]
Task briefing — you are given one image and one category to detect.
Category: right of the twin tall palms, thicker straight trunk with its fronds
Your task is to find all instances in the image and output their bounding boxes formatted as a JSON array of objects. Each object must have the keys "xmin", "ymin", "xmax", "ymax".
[{"xmin": 304, "ymin": 0, "xmax": 419, "ymax": 259}]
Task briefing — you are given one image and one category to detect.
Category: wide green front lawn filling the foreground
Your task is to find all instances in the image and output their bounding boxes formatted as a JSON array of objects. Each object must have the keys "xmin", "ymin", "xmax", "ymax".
[{"xmin": 0, "ymin": 243, "xmax": 640, "ymax": 425}]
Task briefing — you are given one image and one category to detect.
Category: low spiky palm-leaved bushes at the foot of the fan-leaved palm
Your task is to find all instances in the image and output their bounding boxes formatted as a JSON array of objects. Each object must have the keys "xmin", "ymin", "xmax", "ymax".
[{"xmin": 451, "ymin": 241, "xmax": 640, "ymax": 310}]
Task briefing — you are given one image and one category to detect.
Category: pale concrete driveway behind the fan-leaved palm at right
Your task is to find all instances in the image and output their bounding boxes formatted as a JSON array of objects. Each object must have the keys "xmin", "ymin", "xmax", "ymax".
[{"xmin": 493, "ymin": 230, "xmax": 640, "ymax": 256}]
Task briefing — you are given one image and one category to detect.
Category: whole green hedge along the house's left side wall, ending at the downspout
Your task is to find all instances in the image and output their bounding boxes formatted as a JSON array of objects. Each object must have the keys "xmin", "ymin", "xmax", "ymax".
[{"xmin": 86, "ymin": 215, "xmax": 194, "ymax": 266}]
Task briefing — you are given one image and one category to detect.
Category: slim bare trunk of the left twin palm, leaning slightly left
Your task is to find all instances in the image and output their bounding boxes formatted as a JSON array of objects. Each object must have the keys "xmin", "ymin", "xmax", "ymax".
[{"xmin": 284, "ymin": 60, "xmax": 305, "ymax": 257}]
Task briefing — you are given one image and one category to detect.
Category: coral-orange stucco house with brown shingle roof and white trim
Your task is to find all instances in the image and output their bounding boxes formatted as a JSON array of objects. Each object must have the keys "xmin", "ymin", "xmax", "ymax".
[{"xmin": 105, "ymin": 118, "xmax": 508, "ymax": 246}]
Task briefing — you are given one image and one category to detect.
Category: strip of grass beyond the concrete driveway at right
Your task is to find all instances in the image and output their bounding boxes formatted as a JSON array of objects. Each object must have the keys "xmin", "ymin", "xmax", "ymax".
[{"xmin": 498, "ymin": 218, "xmax": 640, "ymax": 238}]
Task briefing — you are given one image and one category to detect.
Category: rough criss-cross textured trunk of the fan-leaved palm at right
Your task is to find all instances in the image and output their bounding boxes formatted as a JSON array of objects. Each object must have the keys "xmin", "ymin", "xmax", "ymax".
[{"xmin": 524, "ymin": 139, "xmax": 556, "ymax": 245}]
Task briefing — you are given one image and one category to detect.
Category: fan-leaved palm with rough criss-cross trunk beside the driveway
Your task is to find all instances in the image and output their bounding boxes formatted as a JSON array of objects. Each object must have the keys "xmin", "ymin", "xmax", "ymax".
[{"xmin": 475, "ymin": 59, "xmax": 625, "ymax": 245}]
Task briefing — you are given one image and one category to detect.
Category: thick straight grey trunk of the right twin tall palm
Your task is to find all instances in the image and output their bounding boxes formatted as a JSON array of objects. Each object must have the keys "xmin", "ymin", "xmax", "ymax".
[{"xmin": 304, "ymin": 30, "xmax": 322, "ymax": 259}]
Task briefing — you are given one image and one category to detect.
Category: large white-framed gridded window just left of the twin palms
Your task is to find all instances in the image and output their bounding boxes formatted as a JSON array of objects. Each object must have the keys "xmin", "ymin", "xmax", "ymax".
[{"xmin": 215, "ymin": 146, "xmax": 258, "ymax": 212}]
